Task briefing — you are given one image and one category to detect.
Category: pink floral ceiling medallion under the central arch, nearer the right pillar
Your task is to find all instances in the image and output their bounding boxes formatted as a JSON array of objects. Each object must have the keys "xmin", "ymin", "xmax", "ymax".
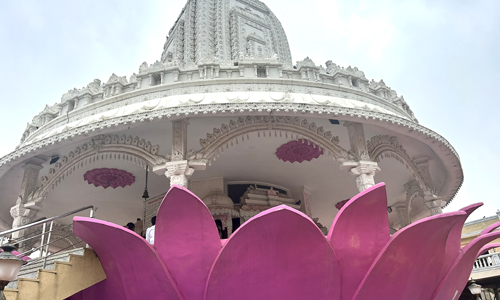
[{"xmin": 276, "ymin": 139, "xmax": 323, "ymax": 163}]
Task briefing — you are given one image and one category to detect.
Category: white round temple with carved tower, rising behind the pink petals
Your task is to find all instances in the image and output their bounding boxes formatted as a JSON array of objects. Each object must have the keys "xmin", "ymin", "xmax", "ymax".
[{"xmin": 0, "ymin": 0, "xmax": 492, "ymax": 298}]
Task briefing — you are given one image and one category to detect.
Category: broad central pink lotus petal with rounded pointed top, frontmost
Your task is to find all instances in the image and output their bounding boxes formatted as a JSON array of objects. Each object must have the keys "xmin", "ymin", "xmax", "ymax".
[{"xmin": 205, "ymin": 205, "xmax": 340, "ymax": 300}]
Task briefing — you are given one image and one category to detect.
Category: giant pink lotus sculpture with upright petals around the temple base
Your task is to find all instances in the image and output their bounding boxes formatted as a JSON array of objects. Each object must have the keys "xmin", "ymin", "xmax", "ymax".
[{"xmin": 70, "ymin": 184, "xmax": 500, "ymax": 300}]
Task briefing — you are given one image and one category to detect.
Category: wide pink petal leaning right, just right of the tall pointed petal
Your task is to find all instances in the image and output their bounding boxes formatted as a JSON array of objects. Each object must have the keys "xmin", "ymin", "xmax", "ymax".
[{"xmin": 353, "ymin": 212, "xmax": 466, "ymax": 300}]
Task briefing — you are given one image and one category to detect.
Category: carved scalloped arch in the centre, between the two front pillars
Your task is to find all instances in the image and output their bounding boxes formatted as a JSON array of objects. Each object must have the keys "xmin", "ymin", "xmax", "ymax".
[{"xmin": 189, "ymin": 116, "xmax": 349, "ymax": 162}]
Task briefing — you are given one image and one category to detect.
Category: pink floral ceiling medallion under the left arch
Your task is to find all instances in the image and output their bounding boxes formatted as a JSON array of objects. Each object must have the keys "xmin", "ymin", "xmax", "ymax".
[{"xmin": 83, "ymin": 168, "xmax": 135, "ymax": 189}]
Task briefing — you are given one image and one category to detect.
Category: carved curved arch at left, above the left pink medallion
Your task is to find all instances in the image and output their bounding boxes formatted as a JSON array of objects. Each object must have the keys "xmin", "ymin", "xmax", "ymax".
[{"xmin": 26, "ymin": 135, "xmax": 170, "ymax": 209}]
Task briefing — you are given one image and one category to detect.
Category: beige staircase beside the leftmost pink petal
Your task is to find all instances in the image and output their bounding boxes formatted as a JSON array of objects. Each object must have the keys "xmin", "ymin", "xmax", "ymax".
[{"xmin": 4, "ymin": 248, "xmax": 106, "ymax": 300}]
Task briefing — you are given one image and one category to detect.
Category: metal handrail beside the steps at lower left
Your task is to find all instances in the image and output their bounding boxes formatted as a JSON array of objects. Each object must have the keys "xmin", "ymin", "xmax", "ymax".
[{"xmin": 0, "ymin": 205, "xmax": 97, "ymax": 268}]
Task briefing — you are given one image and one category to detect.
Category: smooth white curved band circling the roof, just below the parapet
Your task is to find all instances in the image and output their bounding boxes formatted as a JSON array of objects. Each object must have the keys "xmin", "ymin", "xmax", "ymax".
[{"xmin": 20, "ymin": 79, "xmax": 411, "ymax": 146}]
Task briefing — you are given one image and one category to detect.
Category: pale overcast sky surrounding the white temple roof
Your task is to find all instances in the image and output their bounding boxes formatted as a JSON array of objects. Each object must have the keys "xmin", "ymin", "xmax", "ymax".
[{"xmin": 0, "ymin": 0, "xmax": 500, "ymax": 218}]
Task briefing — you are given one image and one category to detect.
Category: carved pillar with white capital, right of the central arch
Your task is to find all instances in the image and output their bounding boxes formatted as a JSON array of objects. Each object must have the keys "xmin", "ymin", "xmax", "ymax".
[{"xmin": 341, "ymin": 122, "xmax": 380, "ymax": 192}]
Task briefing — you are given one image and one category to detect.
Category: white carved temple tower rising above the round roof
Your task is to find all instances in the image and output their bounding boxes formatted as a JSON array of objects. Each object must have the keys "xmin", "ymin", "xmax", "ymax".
[{"xmin": 161, "ymin": 0, "xmax": 292, "ymax": 66}]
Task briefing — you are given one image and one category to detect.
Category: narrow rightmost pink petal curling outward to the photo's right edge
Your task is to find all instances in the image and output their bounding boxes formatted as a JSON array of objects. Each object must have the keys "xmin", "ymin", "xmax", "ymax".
[{"xmin": 430, "ymin": 231, "xmax": 500, "ymax": 300}]
